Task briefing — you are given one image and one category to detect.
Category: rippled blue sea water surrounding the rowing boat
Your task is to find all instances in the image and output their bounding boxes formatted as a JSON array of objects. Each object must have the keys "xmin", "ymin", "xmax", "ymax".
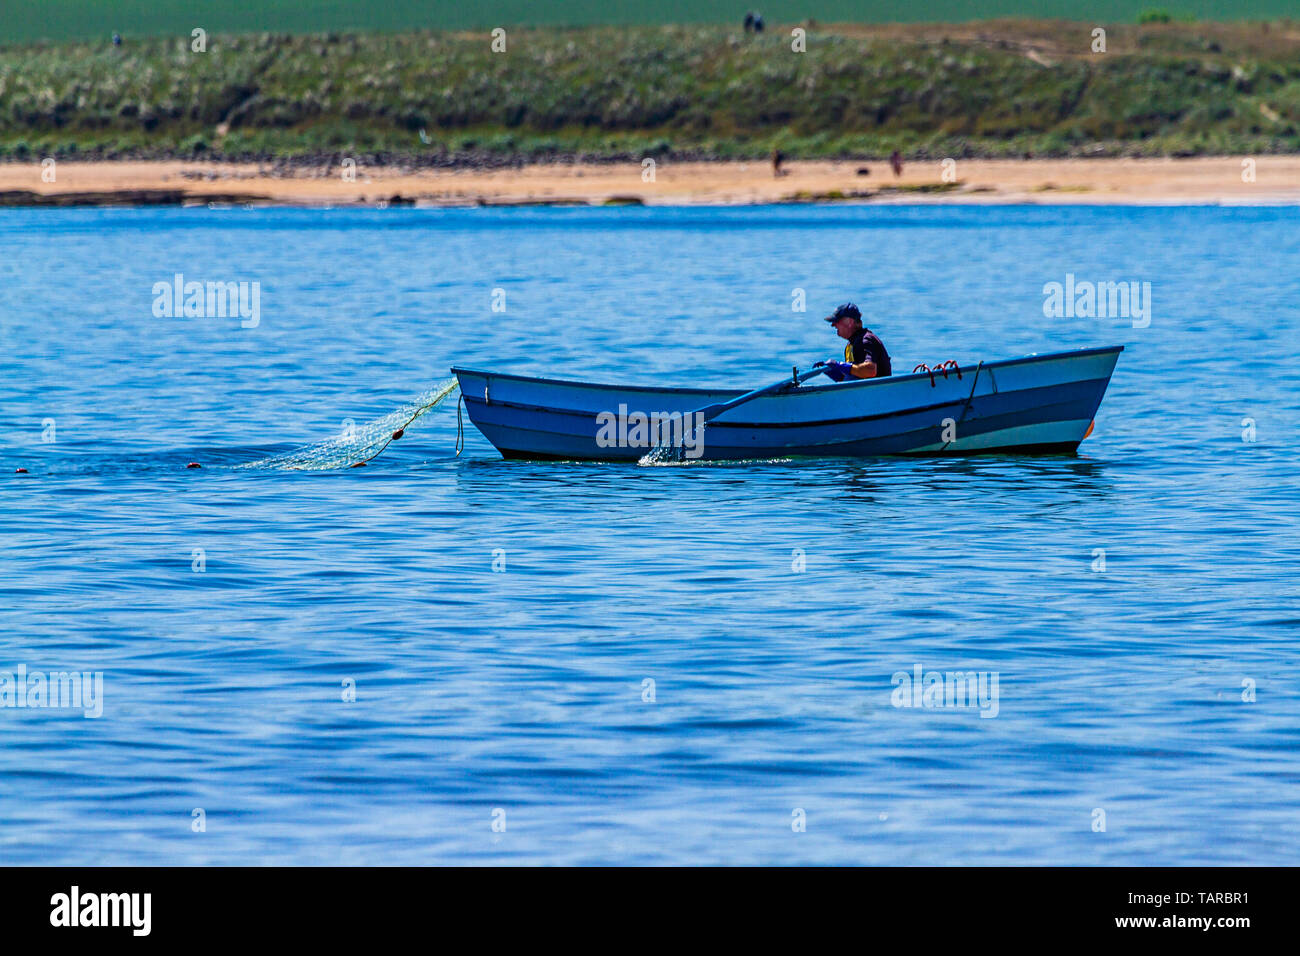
[{"xmin": 0, "ymin": 207, "xmax": 1300, "ymax": 865}]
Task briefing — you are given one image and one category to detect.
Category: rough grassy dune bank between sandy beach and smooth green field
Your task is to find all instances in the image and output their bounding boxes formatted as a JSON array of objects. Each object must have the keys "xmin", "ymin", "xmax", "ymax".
[{"xmin": 0, "ymin": 21, "xmax": 1300, "ymax": 165}]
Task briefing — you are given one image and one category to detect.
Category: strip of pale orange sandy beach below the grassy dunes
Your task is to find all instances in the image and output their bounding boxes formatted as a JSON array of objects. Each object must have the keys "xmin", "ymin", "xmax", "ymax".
[{"xmin": 0, "ymin": 156, "xmax": 1300, "ymax": 207}]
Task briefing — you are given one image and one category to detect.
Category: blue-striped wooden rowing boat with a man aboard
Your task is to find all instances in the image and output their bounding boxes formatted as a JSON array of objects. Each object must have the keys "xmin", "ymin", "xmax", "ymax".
[{"xmin": 451, "ymin": 346, "xmax": 1123, "ymax": 462}]
